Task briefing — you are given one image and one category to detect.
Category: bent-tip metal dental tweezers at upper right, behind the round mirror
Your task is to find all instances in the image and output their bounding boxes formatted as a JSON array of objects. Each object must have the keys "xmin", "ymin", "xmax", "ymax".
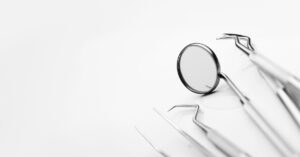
[{"xmin": 218, "ymin": 33, "xmax": 300, "ymax": 127}]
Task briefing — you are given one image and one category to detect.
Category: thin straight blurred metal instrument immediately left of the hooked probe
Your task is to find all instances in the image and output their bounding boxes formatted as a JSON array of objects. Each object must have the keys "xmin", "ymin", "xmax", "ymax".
[{"xmin": 154, "ymin": 109, "xmax": 216, "ymax": 157}]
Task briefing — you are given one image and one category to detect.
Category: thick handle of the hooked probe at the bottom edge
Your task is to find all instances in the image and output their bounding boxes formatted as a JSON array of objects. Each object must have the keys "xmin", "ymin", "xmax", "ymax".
[{"xmin": 207, "ymin": 130, "xmax": 250, "ymax": 157}]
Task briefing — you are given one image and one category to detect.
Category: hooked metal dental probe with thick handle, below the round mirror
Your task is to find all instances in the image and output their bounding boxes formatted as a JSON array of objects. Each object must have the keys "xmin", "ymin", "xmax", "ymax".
[{"xmin": 169, "ymin": 105, "xmax": 250, "ymax": 157}]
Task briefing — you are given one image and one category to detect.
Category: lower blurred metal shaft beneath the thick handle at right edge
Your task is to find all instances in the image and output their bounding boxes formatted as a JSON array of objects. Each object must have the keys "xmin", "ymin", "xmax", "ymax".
[{"xmin": 258, "ymin": 70, "xmax": 300, "ymax": 128}]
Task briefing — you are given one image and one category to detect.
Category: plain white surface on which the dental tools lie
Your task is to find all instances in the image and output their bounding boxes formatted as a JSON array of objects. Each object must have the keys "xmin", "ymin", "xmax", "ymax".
[{"xmin": 0, "ymin": 0, "xmax": 300, "ymax": 157}]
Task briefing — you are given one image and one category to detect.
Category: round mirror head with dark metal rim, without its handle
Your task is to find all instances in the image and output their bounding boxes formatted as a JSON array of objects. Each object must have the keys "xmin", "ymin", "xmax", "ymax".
[{"xmin": 177, "ymin": 43, "xmax": 220, "ymax": 94}]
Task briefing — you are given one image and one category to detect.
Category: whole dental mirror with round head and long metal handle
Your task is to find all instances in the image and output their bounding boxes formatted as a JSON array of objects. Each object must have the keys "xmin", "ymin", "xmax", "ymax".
[{"xmin": 177, "ymin": 43, "xmax": 300, "ymax": 157}]
